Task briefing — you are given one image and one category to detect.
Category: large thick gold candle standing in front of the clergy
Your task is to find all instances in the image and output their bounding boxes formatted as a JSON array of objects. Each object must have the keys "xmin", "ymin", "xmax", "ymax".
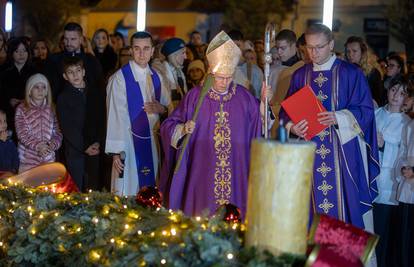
[{"xmin": 246, "ymin": 139, "xmax": 315, "ymax": 255}]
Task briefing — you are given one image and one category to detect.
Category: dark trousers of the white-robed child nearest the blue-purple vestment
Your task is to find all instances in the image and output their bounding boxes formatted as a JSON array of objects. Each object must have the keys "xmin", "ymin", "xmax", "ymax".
[{"xmin": 373, "ymin": 203, "xmax": 400, "ymax": 267}]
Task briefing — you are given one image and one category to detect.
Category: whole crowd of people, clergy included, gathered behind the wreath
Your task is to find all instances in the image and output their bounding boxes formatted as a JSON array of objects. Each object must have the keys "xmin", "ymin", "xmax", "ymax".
[{"xmin": 0, "ymin": 22, "xmax": 414, "ymax": 266}]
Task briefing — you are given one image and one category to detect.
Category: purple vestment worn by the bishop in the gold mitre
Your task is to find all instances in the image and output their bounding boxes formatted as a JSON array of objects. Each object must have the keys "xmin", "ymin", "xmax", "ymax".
[{"xmin": 160, "ymin": 83, "xmax": 261, "ymax": 216}]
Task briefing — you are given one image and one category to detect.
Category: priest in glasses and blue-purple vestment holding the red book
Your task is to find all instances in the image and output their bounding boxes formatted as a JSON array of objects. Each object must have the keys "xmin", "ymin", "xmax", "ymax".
[{"xmin": 280, "ymin": 24, "xmax": 380, "ymax": 231}]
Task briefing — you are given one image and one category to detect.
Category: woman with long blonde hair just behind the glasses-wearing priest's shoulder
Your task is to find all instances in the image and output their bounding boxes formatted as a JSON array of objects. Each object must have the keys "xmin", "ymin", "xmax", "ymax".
[{"xmin": 345, "ymin": 36, "xmax": 386, "ymax": 106}]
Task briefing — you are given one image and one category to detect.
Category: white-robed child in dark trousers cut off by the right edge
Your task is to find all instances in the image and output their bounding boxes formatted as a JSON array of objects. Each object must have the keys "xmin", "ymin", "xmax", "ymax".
[{"xmin": 395, "ymin": 92, "xmax": 414, "ymax": 267}]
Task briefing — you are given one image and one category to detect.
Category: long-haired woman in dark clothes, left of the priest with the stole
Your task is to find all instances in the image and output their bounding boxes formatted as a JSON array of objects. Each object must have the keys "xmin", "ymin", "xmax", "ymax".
[{"xmin": 92, "ymin": 29, "xmax": 118, "ymax": 78}]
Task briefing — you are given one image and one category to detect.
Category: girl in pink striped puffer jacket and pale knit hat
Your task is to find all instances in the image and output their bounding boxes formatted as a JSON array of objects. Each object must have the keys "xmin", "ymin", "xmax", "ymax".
[{"xmin": 15, "ymin": 73, "xmax": 62, "ymax": 172}]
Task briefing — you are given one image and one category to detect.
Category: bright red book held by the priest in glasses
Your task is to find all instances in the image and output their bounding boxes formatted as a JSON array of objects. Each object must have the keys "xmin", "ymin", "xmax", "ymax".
[{"xmin": 281, "ymin": 85, "xmax": 328, "ymax": 140}]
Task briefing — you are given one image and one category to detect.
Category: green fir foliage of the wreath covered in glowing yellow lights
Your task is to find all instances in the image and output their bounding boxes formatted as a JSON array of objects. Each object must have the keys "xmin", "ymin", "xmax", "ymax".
[{"xmin": 0, "ymin": 185, "xmax": 305, "ymax": 267}]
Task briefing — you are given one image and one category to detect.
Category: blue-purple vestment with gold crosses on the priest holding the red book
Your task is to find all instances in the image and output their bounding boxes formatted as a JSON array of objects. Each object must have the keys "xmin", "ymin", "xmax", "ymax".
[{"xmin": 280, "ymin": 59, "xmax": 380, "ymax": 228}]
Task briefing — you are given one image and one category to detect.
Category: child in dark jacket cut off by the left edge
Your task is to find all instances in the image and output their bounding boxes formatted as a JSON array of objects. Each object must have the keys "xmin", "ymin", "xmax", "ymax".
[{"xmin": 0, "ymin": 110, "xmax": 19, "ymax": 177}]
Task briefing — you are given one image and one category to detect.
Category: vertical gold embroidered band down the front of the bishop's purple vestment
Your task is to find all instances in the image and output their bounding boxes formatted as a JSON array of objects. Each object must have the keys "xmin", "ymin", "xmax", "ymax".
[{"xmin": 213, "ymin": 103, "xmax": 231, "ymax": 205}]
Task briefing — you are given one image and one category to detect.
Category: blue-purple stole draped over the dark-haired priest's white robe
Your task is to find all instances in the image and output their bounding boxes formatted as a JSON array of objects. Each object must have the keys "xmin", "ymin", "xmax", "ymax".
[{"xmin": 122, "ymin": 64, "xmax": 161, "ymax": 188}]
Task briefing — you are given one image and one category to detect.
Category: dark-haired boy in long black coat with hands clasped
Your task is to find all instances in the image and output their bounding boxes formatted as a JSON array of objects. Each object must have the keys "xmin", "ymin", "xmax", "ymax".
[{"xmin": 57, "ymin": 57, "xmax": 105, "ymax": 191}]
